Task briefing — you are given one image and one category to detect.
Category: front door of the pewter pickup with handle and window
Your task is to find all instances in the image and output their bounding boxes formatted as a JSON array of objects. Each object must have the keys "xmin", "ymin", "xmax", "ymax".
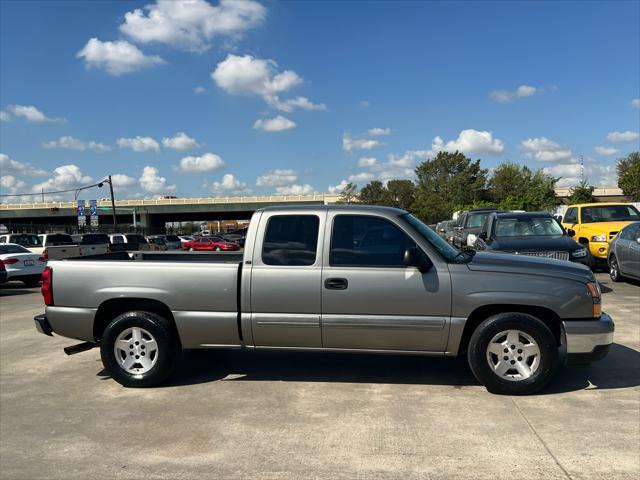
[{"xmin": 322, "ymin": 212, "xmax": 451, "ymax": 352}]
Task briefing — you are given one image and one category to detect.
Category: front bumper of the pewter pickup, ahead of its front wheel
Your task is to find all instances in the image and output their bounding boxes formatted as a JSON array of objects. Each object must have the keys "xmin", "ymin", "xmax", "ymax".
[{"xmin": 562, "ymin": 313, "xmax": 615, "ymax": 366}]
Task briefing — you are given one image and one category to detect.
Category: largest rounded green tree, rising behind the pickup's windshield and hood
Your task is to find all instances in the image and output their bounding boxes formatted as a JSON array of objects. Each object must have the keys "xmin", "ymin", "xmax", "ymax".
[{"xmin": 413, "ymin": 151, "xmax": 487, "ymax": 223}]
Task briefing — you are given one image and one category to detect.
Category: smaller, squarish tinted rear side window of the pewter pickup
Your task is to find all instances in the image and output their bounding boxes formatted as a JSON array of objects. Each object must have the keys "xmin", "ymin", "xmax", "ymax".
[{"xmin": 262, "ymin": 215, "xmax": 320, "ymax": 266}]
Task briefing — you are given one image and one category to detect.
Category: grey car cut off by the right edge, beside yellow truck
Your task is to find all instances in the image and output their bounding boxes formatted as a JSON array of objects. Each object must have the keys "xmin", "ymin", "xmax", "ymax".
[{"xmin": 609, "ymin": 222, "xmax": 640, "ymax": 282}]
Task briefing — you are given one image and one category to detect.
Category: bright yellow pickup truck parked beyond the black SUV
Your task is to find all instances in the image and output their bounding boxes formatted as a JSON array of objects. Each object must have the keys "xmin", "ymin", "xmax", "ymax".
[{"xmin": 562, "ymin": 203, "xmax": 640, "ymax": 269}]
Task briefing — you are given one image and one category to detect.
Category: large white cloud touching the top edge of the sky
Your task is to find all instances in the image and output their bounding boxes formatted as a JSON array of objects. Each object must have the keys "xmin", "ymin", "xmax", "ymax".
[{"xmin": 120, "ymin": 0, "xmax": 267, "ymax": 53}]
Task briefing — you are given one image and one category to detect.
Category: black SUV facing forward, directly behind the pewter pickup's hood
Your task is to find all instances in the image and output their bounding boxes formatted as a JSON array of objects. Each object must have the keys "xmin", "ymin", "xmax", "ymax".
[{"xmin": 475, "ymin": 212, "xmax": 587, "ymax": 263}]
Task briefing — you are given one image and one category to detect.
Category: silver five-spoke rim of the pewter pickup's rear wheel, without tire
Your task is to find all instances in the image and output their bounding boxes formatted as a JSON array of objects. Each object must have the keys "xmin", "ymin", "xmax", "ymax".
[{"xmin": 113, "ymin": 327, "xmax": 158, "ymax": 375}]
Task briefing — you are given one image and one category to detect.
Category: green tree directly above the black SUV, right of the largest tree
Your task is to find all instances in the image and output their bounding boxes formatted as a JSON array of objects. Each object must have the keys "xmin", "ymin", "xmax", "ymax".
[{"xmin": 489, "ymin": 162, "xmax": 558, "ymax": 211}]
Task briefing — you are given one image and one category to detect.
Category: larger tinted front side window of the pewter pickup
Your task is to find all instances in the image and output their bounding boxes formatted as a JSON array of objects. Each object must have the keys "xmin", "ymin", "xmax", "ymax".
[{"xmin": 329, "ymin": 215, "xmax": 416, "ymax": 268}]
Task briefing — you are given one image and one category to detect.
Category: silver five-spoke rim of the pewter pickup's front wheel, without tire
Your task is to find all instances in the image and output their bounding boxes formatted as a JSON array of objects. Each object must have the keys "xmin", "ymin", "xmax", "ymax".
[{"xmin": 487, "ymin": 330, "xmax": 541, "ymax": 382}]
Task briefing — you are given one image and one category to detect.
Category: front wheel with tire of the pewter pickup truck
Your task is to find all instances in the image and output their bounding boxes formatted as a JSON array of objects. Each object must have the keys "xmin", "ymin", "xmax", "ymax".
[{"xmin": 467, "ymin": 312, "xmax": 558, "ymax": 395}]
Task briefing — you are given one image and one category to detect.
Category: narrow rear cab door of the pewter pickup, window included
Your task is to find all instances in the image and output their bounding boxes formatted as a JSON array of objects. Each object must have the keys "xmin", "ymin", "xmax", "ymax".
[{"xmin": 250, "ymin": 210, "xmax": 326, "ymax": 348}]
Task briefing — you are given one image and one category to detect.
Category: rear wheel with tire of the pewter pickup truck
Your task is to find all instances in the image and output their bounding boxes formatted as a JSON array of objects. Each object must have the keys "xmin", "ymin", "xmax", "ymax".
[{"xmin": 100, "ymin": 311, "xmax": 180, "ymax": 387}]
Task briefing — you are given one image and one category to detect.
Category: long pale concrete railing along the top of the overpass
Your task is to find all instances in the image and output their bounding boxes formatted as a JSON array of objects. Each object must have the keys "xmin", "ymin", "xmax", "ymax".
[{"xmin": 0, "ymin": 194, "xmax": 340, "ymax": 210}]
